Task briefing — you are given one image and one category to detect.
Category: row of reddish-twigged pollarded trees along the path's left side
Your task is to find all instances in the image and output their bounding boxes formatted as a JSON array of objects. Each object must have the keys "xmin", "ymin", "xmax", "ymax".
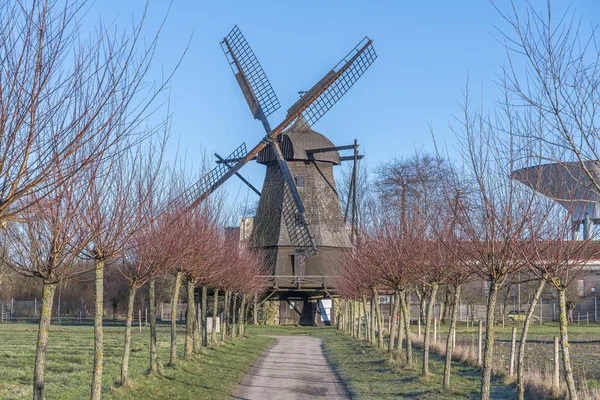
[{"xmin": 3, "ymin": 125, "xmax": 264, "ymax": 399}]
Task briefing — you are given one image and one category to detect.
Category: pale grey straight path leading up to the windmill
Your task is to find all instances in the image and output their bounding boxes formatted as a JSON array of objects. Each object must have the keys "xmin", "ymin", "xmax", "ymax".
[{"xmin": 231, "ymin": 336, "xmax": 348, "ymax": 400}]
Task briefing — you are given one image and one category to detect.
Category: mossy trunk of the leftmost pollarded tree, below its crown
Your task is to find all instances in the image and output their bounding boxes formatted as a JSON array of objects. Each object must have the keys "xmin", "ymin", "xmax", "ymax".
[{"xmin": 33, "ymin": 282, "xmax": 57, "ymax": 400}]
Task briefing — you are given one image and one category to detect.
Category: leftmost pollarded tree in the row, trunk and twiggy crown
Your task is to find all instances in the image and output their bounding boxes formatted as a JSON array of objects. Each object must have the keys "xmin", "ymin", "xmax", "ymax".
[{"xmin": 1, "ymin": 170, "xmax": 93, "ymax": 399}]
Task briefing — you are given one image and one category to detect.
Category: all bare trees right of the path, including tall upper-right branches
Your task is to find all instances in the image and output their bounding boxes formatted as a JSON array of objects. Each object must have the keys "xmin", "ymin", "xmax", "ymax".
[{"xmin": 336, "ymin": 1, "xmax": 600, "ymax": 399}]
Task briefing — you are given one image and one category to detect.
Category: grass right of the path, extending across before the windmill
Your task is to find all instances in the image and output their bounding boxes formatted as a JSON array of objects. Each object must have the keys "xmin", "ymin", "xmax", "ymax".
[{"xmin": 249, "ymin": 326, "xmax": 516, "ymax": 399}]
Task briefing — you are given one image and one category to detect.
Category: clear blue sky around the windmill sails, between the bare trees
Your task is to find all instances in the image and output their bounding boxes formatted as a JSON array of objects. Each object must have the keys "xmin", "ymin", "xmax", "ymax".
[{"xmin": 86, "ymin": 0, "xmax": 600, "ymax": 211}]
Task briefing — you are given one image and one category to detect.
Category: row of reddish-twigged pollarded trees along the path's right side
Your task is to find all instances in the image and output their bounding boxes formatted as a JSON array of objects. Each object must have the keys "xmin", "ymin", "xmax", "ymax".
[{"xmin": 336, "ymin": 149, "xmax": 600, "ymax": 398}]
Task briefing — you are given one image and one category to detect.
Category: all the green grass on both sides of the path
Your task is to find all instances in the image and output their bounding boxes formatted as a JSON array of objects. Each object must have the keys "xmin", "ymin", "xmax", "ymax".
[{"xmin": 0, "ymin": 324, "xmax": 600, "ymax": 399}]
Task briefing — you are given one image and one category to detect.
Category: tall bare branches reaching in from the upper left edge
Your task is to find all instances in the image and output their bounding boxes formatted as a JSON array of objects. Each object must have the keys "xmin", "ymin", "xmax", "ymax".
[{"xmin": 0, "ymin": 0, "xmax": 164, "ymax": 227}]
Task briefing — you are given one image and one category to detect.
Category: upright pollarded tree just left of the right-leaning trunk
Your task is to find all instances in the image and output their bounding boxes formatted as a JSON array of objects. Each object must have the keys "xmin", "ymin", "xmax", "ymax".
[{"xmin": 452, "ymin": 93, "xmax": 536, "ymax": 400}]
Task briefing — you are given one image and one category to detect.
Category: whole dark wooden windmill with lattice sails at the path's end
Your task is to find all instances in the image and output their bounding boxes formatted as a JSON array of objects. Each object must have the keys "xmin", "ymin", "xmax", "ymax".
[{"xmin": 181, "ymin": 26, "xmax": 377, "ymax": 319}]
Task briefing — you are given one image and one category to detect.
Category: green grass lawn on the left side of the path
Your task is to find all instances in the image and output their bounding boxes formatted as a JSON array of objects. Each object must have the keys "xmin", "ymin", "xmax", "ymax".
[{"xmin": 0, "ymin": 324, "xmax": 273, "ymax": 399}]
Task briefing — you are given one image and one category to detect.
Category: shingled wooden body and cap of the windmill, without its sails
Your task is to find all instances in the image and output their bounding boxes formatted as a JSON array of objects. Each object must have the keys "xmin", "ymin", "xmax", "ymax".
[{"xmin": 251, "ymin": 119, "xmax": 350, "ymax": 277}]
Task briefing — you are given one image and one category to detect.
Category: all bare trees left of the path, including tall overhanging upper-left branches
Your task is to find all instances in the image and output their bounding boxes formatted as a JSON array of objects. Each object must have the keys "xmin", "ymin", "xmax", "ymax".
[{"xmin": 0, "ymin": 0, "xmax": 263, "ymax": 399}]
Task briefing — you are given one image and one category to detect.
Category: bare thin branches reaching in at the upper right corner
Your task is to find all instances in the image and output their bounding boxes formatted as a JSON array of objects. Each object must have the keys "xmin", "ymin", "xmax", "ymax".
[{"xmin": 496, "ymin": 0, "xmax": 600, "ymax": 194}]
